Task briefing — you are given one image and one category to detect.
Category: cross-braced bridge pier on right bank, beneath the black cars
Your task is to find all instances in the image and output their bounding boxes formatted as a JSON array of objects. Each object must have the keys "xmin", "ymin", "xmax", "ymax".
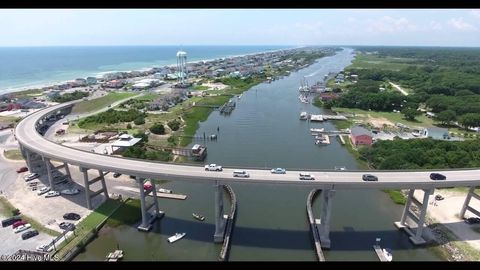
[{"xmin": 394, "ymin": 189, "xmax": 433, "ymax": 245}]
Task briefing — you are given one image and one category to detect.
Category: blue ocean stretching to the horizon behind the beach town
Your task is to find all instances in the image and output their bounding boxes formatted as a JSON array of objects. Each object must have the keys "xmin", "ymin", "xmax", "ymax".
[{"xmin": 0, "ymin": 46, "xmax": 292, "ymax": 94}]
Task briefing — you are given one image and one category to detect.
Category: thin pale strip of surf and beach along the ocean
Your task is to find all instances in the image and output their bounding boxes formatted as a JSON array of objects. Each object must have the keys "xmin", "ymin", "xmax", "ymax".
[{"xmin": 0, "ymin": 46, "xmax": 294, "ymax": 96}]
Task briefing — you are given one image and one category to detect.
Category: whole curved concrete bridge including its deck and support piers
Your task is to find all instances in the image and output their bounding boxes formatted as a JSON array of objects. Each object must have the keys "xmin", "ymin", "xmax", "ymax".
[{"xmin": 15, "ymin": 101, "xmax": 480, "ymax": 253}]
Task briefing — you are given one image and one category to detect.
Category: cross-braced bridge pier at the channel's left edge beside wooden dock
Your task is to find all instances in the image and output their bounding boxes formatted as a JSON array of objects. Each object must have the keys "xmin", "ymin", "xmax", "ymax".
[{"xmin": 135, "ymin": 176, "xmax": 164, "ymax": 232}]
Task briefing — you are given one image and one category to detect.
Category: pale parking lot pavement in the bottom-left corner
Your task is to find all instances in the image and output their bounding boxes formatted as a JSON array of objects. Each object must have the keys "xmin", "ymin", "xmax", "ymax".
[{"xmin": 0, "ymin": 216, "xmax": 54, "ymax": 261}]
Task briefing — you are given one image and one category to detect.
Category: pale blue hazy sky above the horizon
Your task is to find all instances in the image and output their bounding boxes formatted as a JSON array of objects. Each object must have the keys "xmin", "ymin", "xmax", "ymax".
[{"xmin": 0, "ymin": 9, "xmax": 480, "ymax": 47}]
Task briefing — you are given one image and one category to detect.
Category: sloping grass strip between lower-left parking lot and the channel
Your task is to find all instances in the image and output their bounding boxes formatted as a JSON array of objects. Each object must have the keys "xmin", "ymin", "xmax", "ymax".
[{"xmin": 54, "ymin": 199, "xmax": 122, "ymax": 258}]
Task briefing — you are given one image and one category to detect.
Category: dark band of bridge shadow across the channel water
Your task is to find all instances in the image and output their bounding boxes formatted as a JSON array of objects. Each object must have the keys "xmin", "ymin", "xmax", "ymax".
[{"xmin": 143, "ymin": 216, "xmax": 480, "ymax": 251}]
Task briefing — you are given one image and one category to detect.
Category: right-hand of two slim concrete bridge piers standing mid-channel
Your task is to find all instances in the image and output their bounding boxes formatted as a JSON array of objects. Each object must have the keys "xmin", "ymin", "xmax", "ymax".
[{"xmin": 317, "ymin": 189, "xmax": 335, "ymax": 249}]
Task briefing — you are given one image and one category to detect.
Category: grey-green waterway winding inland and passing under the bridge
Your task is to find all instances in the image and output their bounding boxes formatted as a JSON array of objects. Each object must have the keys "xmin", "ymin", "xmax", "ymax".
[{"xmin": 75, "ymin": 48, "xmax": 441, "ymax": 261}]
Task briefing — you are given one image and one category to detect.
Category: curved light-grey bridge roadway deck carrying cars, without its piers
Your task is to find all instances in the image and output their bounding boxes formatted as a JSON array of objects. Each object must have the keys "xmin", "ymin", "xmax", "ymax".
[{"xmin": 15, "ymin": 102, "xmax": 480, "ymax": 189}]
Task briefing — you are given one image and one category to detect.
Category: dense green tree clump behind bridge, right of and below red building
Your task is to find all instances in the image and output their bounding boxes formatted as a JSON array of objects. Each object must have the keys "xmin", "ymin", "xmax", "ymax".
[{"xmin": 359, "ymin": 139, "xmax": 480, "ymax": 170}]
